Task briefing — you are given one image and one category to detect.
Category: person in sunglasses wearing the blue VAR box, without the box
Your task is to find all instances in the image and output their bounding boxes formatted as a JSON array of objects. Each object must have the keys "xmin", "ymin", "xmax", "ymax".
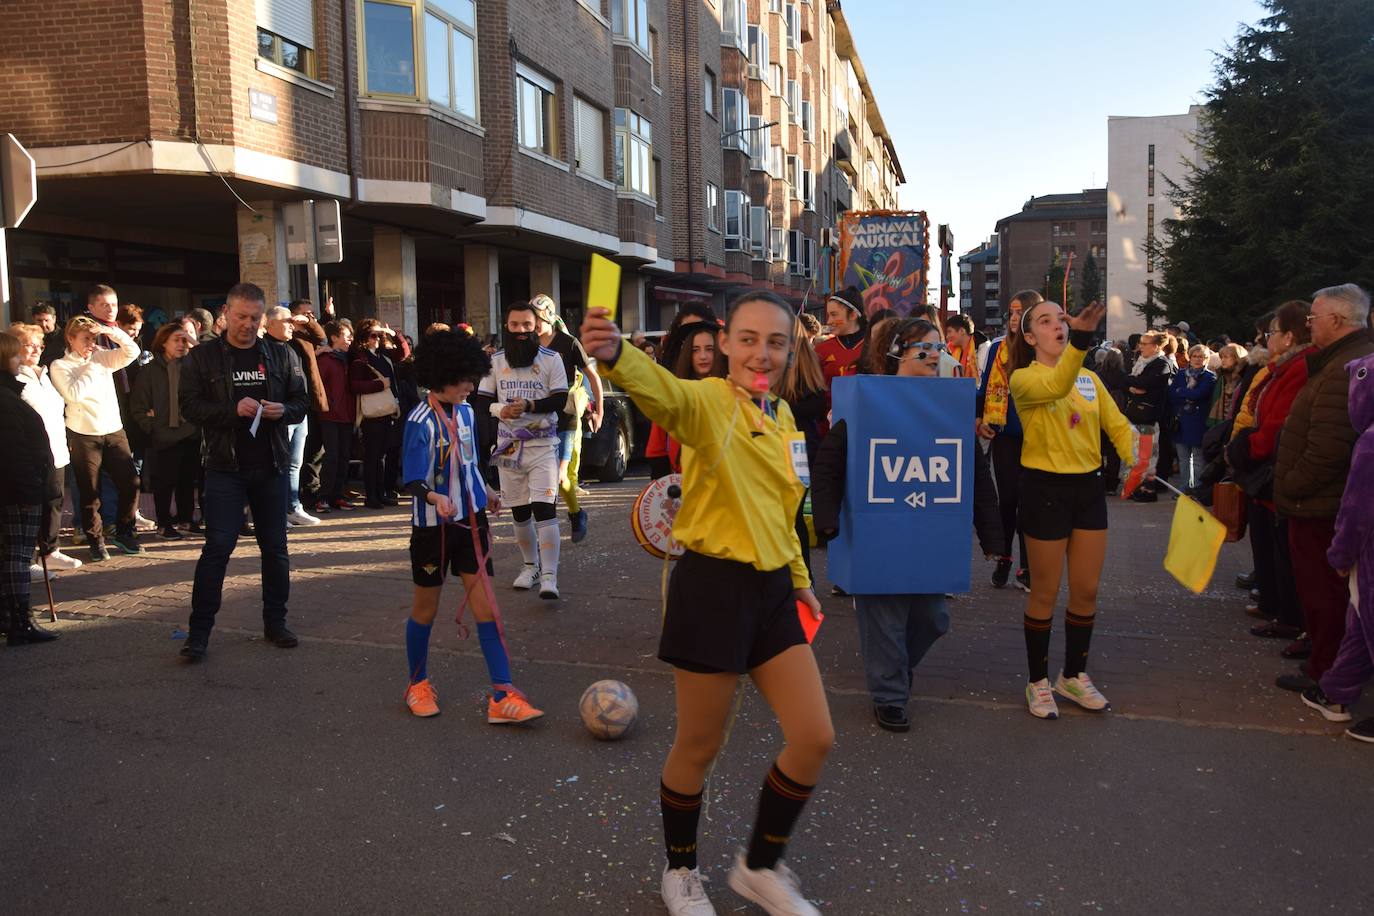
[{"xmin": 812, "ymin": 319, "xmax": 949, "ymax": 732}]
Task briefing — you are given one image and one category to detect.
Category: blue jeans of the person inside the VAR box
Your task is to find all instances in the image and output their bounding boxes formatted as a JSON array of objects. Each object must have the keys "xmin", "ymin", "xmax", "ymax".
[{"xmin": 855, "ymin": 595, "xmax": 949, "ymax": 707}]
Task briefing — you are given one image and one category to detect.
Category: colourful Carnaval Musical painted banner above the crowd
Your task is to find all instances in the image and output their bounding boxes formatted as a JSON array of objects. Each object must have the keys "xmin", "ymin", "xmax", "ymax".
[{"xmin": 838, "ymin": 210, "xmax": 930, "ymax": 316}]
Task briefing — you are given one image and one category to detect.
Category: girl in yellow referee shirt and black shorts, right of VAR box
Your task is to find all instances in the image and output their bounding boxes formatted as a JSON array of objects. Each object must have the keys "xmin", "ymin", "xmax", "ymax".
[{"xmin": 1011, "ymin": 302, "xmax": 1135, "ymax": 718}]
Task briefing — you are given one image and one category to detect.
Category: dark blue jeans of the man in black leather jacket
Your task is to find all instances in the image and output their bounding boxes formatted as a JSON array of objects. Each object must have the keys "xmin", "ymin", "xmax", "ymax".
[{"xmin": 190, "ymin": 466, "xmax": 291, "ymax": 636}]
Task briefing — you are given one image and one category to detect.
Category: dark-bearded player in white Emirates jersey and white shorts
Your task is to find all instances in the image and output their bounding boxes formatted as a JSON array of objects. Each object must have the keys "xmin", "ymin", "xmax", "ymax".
[{"xmin": 477, "ymin": 302, "xmax": 567, "ymax": 600}]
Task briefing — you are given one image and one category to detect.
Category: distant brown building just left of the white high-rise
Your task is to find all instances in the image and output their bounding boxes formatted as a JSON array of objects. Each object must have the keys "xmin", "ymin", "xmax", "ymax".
[{"xmin": 996, "ymin": 188, "xmax": 1107, "ymax": 314}]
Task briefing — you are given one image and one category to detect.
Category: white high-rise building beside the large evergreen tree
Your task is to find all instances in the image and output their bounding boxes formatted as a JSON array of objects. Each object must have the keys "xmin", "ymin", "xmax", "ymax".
[{"xmin": 1107, "ymin": 104, "xmax": 1202, "ymax": 338}]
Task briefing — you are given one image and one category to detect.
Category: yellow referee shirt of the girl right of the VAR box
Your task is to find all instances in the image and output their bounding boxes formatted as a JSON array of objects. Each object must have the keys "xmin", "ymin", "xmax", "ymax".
[{"xmin": 1011, "ymin": 342, "xmax": 1135, "ymax": 474}]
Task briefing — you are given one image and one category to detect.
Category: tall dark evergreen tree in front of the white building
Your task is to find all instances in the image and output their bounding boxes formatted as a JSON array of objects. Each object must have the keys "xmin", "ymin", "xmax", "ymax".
[{"xmin": 1159, "ymin": 0, "xmax": 1374, "ymax": 338}]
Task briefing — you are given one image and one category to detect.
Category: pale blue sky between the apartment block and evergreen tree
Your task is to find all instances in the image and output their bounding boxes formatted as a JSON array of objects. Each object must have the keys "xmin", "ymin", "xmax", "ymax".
[{"xmin": 844, "ymin": 0, "xmax": 1264, "ymax": 258}]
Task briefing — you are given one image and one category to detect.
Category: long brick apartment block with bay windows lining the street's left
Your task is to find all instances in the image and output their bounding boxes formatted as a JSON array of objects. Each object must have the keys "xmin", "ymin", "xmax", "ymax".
[{"xmin": 0, "ymin": 0, "xmax": 903, "ymax": 334}]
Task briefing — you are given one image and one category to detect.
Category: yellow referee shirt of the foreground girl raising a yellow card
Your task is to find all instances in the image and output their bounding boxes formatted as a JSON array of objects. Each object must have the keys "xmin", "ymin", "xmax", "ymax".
[{"xmin": 602, "ymin": 346, "xmax": 811, "ymax": 588}]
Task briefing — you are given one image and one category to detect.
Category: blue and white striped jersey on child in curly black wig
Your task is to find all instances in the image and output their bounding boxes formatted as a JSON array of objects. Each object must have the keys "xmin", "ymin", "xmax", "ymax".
[{"xmin": 401, "ymin": 400, "xmax": 486, "ymax": 527}]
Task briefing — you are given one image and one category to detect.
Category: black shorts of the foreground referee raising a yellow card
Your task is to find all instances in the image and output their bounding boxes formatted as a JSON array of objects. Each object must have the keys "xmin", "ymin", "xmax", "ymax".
[{"xmin": 658, "ymin": 551, "xmax": 807, "ymax": 674}]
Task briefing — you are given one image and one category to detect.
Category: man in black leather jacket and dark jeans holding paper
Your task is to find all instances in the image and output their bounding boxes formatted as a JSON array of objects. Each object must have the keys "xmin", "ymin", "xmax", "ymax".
[{"xmin": 180, "ymin": 283, "xmax": 309, "ymax": 661}]
